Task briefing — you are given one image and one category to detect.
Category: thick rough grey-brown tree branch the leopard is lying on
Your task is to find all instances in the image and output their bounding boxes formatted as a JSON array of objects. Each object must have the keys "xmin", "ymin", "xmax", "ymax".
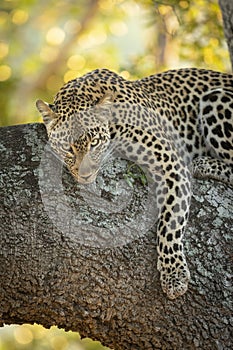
[{"xmin": 0, "ymin": 124, "xmax": 233, "ymax": 350}]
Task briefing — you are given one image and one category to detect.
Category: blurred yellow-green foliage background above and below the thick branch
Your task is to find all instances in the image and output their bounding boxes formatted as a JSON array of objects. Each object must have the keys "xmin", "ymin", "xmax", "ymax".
[{"xmin": 0, "ymin": 0, "xmax": 231, "ymax": 350}]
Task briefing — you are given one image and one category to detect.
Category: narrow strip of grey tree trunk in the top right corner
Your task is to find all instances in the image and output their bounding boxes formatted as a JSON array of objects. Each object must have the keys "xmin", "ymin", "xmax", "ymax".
[{"xmin": 219, "ymin": 0, "xmax": 233, "ymax": 70}]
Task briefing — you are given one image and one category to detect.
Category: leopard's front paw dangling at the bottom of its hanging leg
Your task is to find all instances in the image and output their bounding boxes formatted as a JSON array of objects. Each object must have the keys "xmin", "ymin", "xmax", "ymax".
[{"xmin": 159, "ymin": 262, "xmax": 190, "ymax": 299}]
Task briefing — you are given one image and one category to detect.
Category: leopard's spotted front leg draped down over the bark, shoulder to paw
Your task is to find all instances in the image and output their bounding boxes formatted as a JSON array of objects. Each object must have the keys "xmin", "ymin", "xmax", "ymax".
[{"xmin": 115, "ymin": 125, "xmax": 191, "ymax": 299}]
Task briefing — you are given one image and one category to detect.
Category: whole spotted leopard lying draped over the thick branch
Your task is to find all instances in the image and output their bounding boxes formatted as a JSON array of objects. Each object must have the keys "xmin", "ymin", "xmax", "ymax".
[{"xmin": 36, "ymin": 68, "xmax": 233, "ymax": 300}]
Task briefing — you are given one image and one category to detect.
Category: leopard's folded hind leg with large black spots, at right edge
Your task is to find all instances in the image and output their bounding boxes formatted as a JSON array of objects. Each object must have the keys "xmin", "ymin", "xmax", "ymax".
[{"xmin": 193, "ymin": 89, "xmax": 233, "ymax": 186}]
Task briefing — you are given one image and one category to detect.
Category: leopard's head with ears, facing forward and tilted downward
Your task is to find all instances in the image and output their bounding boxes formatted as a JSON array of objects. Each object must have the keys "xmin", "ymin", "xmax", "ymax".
[{"xmin": 36, "ymin": 96, "xmax": 111, "ymax": 184}]
